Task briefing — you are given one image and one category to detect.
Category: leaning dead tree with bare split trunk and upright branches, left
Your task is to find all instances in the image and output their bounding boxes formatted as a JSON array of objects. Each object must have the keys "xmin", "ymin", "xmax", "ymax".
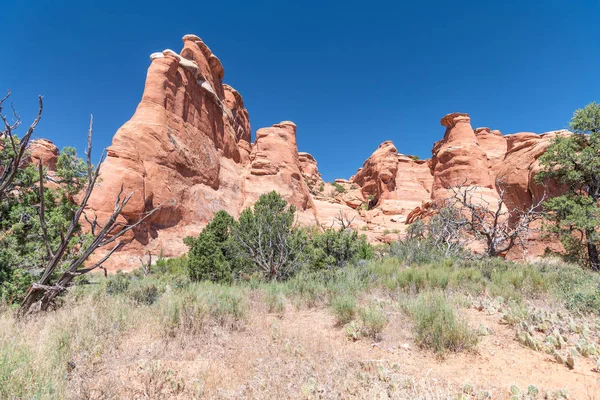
[{"xmin": 20, "ymin": 118, "xmax": 160, "ymax": 315}]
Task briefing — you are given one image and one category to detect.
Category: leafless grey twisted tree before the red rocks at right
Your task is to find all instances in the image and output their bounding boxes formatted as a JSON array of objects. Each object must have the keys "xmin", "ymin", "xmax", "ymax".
[{"xmin": 450, "ymin": 180, "xmax": 546, "ymax": 257}]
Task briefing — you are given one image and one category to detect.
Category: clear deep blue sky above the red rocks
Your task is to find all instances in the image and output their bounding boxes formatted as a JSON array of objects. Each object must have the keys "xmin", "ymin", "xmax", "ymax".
[{"xmin": 0, "ymin": 0, "xmax": 600, "ymax": 180}]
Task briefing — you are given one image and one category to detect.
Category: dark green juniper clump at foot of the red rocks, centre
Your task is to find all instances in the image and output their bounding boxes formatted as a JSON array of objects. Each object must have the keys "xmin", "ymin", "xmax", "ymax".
[{"xmin": 183, "ymin": 192, "xmax": 375, "ymax": 283}]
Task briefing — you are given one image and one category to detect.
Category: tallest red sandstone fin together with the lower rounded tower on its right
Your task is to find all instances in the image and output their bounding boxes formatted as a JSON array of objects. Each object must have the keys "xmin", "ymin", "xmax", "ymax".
[{"xmin": 89, "ymin": 35, "xmax": 314, "ymax": 267}]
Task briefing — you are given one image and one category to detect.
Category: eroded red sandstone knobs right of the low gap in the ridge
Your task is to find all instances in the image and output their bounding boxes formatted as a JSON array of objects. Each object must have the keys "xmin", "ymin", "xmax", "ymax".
[{"xmin": 342, "ymin": 113, "xmax": 570, "ymax": 259}]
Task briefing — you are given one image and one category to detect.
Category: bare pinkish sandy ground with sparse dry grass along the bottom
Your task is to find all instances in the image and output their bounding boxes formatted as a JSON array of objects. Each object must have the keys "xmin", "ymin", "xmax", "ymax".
[{"xmin": 73, "ymin": 303, "xmax": 600, "ymax": 399}]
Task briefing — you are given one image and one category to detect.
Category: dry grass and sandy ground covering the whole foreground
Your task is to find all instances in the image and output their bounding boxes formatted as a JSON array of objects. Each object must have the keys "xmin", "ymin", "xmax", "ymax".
[{"xmin": 0, "ymin": 255, "xmax": 597, "ymax": 399}]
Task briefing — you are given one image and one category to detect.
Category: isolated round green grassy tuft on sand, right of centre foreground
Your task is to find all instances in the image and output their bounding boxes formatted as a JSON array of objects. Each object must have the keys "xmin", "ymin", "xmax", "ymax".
[{"xmin": 407, "ymin": 292, "xmax": 478, "ymax": 356}]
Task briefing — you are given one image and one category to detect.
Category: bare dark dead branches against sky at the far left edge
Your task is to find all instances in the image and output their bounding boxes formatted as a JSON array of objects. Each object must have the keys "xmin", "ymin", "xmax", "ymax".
[{"xmin": 0, "ymin": 90, "xmax": 44, "ymax": 199}]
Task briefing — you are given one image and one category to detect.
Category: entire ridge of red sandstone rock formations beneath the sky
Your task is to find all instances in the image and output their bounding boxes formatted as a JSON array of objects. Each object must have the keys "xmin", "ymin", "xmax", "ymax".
[{"xmin": 32, "ymin": 35, "xmax": 563, "ymax": 268}]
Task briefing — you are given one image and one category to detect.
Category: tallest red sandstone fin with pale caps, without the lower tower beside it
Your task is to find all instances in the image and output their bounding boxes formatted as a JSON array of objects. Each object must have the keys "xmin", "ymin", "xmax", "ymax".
[{"xmin": 84, "ymin": 35, "xmax": 249, "ymax": 255}]
